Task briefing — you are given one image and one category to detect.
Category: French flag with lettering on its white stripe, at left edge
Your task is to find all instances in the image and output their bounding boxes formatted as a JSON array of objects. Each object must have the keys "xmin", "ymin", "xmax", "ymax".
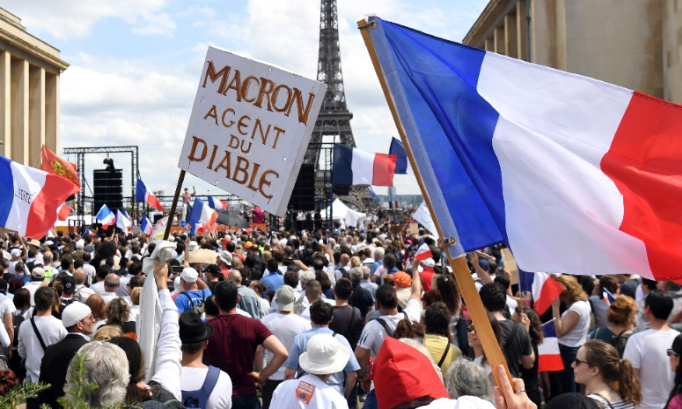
[{"xmin": 0, "ymin": 156, "xmax": 77, "ymax": 239}]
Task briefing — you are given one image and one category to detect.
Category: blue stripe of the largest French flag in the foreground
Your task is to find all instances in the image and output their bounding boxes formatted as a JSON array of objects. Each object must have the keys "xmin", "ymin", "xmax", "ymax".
[{"xmin": 370, "ymin": 17, "xmax": 507, "ymax": 251}]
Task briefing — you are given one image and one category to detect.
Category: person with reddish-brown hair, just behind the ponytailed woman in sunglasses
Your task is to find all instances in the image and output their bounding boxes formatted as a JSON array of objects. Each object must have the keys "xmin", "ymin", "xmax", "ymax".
[{"xmin": 592, "ymin": 294, "xmax": 637, "ymax": 357}]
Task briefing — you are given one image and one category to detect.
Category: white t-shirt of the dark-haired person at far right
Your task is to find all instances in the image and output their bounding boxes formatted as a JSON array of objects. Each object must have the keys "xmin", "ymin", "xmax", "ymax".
[{"xmin": 623, "ymin": 329, "xmax": 680, "ymax": 409}]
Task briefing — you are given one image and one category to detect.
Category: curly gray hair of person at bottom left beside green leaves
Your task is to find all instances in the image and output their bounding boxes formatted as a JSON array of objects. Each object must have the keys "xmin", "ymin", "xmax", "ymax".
[{"xmin": 64, "ymin": 341, "xmax": 130, "ymax": 408}]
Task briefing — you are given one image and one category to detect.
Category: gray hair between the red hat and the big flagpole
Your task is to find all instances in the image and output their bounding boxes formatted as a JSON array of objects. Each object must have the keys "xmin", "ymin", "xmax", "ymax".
[{"xmin": 445, "ymin": 358, "xmax": 491, "ymax": 400}]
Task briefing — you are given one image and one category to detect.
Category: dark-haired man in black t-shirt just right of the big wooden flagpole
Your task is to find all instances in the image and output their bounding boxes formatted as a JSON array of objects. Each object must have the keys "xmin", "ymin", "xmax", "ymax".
[{"xmin": 479, "ymin": 283, "xmax": 535, "ymax": 377}]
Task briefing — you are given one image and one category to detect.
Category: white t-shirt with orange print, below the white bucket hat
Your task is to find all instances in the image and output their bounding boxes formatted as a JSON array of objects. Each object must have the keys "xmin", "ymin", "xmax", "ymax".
[{"xmin": 270, "ymin": 374, "xmax": 348, "ymax": 409}]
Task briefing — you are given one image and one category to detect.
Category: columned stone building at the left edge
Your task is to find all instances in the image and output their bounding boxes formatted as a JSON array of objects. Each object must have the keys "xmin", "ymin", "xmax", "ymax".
[{"xmin": 0, "ymin": 8, "xmax": 69, "ymax": 167}]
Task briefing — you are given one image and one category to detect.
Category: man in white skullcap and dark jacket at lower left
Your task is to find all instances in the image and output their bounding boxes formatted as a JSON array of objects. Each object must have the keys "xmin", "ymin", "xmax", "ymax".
[{"xmin": 37, "ymin": 300, "xmax": 95, "ymax": 408}]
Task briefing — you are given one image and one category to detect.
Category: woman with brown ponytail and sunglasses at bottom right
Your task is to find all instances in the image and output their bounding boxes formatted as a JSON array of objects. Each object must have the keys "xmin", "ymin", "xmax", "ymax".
[{"xmin": 571, "ymin": 340, "xmax": 642, "ymax": 409}]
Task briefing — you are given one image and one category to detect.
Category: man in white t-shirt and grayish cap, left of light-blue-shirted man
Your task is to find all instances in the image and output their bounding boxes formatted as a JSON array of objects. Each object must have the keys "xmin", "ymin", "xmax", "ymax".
[{"xmin": 262, "ymin": 285, "xmax": 311, "ymax": 409}]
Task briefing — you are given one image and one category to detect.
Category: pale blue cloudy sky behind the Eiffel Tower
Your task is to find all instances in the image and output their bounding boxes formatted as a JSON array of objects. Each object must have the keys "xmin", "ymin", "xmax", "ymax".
[{"xmin": 2, "ymin": 0, "xmax": 488, "ymax": 204}]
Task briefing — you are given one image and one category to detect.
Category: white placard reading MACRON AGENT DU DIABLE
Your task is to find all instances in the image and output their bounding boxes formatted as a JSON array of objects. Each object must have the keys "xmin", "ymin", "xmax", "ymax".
[{"xmin": 178, "ymin": 47, "xmax": 327, "ymax": 216}]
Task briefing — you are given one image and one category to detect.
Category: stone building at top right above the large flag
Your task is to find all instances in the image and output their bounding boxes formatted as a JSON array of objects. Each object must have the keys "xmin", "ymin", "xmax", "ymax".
[{"xmin": 463, "ymin": 0, "xmax": 682, "ymax": 104}]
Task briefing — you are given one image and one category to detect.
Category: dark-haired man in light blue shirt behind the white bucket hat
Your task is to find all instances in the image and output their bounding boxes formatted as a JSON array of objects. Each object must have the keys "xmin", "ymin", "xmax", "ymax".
[{"xmin": 282, "ymin": 300, "xmax": 360, "ymax": 400}]
